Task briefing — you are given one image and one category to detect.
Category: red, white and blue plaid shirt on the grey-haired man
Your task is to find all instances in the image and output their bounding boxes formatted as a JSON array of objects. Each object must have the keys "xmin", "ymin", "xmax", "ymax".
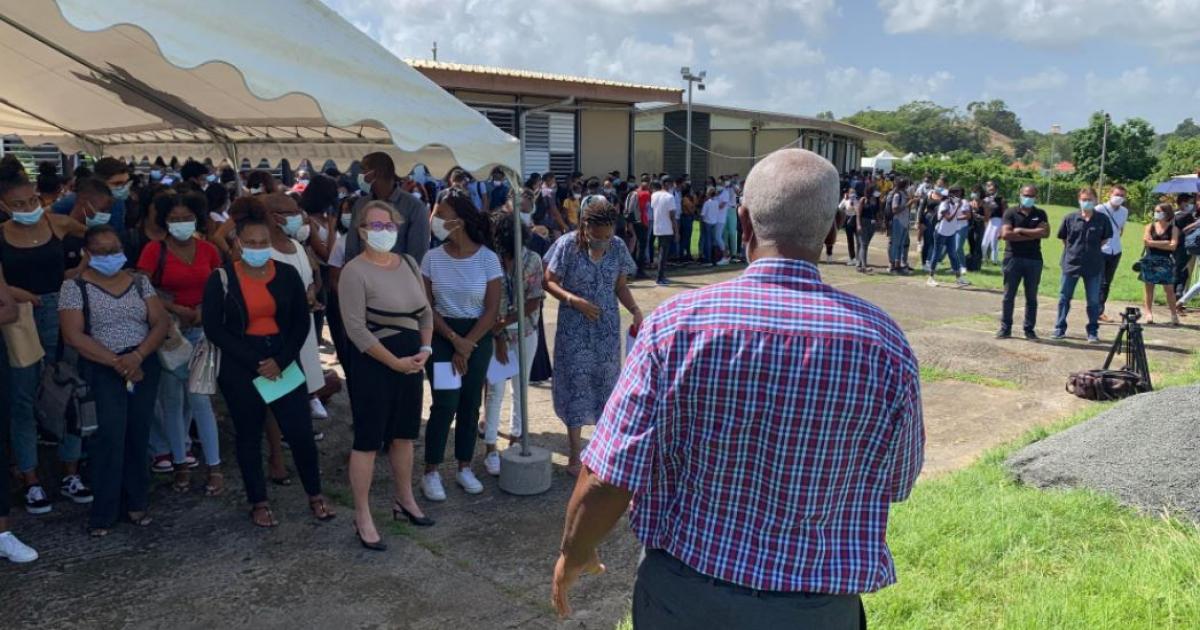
[{"xmin": 583, "ymin": 259, "xmax": 925, "ymax": 594}]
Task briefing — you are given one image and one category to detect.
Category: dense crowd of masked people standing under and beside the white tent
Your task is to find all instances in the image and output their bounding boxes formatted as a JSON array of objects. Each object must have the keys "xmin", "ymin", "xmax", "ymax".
[{"xmin": 0, "ymin": 152, "xmax": 740, "ymax": 562}]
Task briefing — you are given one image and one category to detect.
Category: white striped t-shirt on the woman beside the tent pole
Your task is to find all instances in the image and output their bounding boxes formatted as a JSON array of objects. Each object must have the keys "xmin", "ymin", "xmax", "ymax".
[{"xmin": 421, "ymin": 246, "xmax": 504, "ymax": 319}]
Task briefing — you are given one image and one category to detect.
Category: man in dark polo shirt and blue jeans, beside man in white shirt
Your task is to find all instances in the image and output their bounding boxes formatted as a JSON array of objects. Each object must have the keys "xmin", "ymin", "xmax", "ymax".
[{"xmin": 1054, "ymin": 188, "xmax": 1115, "ymax": 343}]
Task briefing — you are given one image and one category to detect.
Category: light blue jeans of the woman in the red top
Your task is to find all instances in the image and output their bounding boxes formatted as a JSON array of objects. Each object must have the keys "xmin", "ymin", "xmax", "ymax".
[{"xmin": 150, "ymin": 328, "xmax": 221, "ymax": 466}]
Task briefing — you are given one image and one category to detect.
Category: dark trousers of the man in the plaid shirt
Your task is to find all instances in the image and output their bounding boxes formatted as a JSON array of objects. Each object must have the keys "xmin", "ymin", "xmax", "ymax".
[{"xmin": 634, "ymin": 550, "xmax": 866, "ymax": 630}]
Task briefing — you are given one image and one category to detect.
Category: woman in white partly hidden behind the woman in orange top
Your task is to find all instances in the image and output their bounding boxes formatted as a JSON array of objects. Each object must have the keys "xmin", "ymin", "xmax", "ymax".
[{"xmin": 263, "ymin": 193, "xmax": 329, "ymax": 422}]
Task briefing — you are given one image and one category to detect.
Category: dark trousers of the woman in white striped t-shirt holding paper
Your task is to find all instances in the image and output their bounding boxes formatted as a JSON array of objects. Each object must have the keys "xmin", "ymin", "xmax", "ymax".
[{"xmin": 425, "ymin": 319, "xmax": 492, "ymax": 464}]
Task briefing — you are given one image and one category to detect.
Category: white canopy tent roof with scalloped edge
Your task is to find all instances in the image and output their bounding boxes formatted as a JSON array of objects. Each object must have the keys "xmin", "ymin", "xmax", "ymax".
[{"xmin": 0, "ymin": 0, "xmax": 521, "ymax": 175}]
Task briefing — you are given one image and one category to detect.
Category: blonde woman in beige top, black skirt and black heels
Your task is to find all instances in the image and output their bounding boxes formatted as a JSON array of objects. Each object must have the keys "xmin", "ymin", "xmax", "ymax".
[{"xmin": 338, "ymin": 202, "xmax": 433, "ymax": 551}]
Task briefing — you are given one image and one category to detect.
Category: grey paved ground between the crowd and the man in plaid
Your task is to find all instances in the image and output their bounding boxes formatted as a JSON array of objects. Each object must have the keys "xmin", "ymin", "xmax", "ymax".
[{"xmin": 0, "ymin": 253, "xmax": 1200, "ymax": 630}]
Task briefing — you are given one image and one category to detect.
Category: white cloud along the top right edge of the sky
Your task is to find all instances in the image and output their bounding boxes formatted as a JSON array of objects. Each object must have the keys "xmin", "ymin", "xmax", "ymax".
[{"xmin": 878, "ymin": 0, "xmax": 1200, "ymax": 61}]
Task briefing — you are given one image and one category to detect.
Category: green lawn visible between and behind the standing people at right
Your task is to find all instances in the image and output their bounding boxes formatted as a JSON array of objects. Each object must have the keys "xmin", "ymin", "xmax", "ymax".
[{"xmin": 940, "ymin": 205, "xmax": 1166, "ymax": 304}]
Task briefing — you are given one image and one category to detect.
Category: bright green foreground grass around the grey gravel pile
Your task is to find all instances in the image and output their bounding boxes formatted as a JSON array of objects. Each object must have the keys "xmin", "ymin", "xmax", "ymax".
[{"xmin": 617, "ymin": 358, "xmax": 1200, "ymax": 630}]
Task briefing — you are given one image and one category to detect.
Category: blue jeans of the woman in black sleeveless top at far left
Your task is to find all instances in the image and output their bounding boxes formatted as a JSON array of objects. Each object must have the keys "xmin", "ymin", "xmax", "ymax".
[{"xmin": 8, "ymin": 293, "xmax": 83, "ymax": 473}]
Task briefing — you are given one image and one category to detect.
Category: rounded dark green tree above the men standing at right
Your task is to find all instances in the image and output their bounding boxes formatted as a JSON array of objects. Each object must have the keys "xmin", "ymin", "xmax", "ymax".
[{"xmin": 1070, "ymin": 113, "xmax": 1154, "ymax": 181}]
